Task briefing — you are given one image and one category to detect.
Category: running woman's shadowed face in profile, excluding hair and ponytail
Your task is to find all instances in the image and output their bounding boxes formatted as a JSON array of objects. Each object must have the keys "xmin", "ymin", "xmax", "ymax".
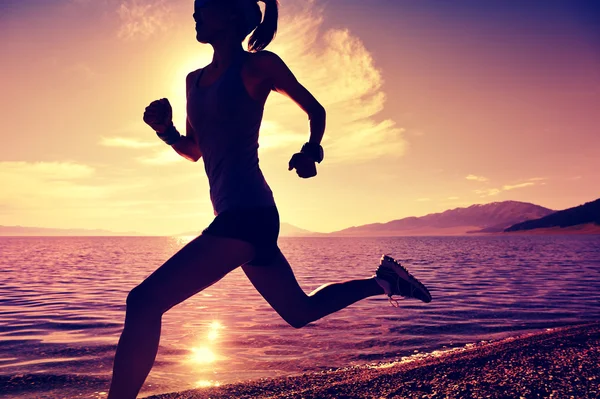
[{"xmin": 193, "ymin": 0, "xmax": 233, "ymax": 43}]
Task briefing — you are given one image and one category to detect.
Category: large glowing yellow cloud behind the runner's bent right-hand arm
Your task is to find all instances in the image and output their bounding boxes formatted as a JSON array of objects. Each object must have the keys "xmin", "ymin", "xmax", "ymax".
[{"xmin": 260, "ymin": 0, "xmax": 406, "ymax": 163}]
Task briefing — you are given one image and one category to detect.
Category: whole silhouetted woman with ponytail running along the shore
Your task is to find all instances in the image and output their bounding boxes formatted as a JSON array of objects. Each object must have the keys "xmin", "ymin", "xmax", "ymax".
[{"xmin": 108, "ymin": 0, "xmax": 431, "ymax": 399}]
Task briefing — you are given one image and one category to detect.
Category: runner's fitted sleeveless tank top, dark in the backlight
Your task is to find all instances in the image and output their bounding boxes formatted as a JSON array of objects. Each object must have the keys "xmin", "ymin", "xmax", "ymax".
[{"xmin": 186, "ymin": 51, "xmax": 275, "ymax": 219}]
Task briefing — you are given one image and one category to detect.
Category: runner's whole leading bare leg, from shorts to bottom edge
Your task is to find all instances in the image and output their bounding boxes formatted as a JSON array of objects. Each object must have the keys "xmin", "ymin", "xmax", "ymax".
[{"xmin": 108, "ymin": 234, "xmax": 254, "ymax": 399}]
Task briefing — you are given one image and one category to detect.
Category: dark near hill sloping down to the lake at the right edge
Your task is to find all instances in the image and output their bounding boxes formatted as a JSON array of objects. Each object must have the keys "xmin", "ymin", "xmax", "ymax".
[{"xmin": 504, "ymin": 199, "xmax": 600, "ymax": 232}]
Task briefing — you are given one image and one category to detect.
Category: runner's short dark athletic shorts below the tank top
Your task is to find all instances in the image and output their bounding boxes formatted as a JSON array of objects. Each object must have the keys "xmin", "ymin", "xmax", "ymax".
[{"xmin": 202, "ymin": 206, "xmax": 279, "ymax": 266}]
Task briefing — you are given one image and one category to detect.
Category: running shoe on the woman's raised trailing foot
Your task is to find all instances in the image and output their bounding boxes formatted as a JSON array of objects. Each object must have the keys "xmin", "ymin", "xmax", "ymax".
[{"xmin": 375, "ymin": 255, "xmax": 431, "ymax": 307}]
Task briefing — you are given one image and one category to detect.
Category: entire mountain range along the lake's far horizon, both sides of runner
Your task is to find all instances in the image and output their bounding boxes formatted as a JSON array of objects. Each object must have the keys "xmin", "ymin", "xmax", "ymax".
[{"xmin": 0, "ymin": 199, "xmax": 600, "ymax": 237}]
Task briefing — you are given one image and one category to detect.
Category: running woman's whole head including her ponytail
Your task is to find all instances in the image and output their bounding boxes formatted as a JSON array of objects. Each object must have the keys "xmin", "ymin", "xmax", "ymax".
[{"xmin": 193, "ymin": 0, "xmax": 279, "ymax": 52}]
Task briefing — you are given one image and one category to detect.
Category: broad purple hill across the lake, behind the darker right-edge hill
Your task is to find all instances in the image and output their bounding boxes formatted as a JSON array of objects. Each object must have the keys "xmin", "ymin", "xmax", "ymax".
[{"xmin": 329, "ymin": 201, "xmax": 554, "ymax": 236}]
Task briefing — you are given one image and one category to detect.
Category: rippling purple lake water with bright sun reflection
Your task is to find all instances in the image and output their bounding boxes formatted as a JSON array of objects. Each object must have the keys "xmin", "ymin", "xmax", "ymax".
[{"xmin": 0, "ymin": 235, "xmax": 600, "ymax": 398}]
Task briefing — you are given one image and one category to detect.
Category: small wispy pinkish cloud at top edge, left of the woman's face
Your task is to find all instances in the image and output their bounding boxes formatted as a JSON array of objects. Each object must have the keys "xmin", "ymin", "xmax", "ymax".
[{"xmin": 117, "ymin": 0, "xmax": 173, "ymax": 40}]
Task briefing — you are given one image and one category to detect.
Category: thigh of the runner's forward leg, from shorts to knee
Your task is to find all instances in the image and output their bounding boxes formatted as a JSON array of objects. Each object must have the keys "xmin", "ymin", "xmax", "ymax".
[{"xmin": 128, "ymin": 234, "xmax": 255, "ymax": 313}]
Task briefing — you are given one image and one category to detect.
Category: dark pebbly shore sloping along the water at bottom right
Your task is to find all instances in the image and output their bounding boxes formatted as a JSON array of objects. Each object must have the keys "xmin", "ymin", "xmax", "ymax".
[{"xmin": 148, "ymin": 322, "xmax": 600, "ymax": 399}]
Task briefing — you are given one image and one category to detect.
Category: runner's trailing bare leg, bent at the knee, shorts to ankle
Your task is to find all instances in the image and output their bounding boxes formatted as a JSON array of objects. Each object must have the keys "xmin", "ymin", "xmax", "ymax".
[{"xmin": 242, "ymin": 251, "xmax": 384, "ymax": 328}]
